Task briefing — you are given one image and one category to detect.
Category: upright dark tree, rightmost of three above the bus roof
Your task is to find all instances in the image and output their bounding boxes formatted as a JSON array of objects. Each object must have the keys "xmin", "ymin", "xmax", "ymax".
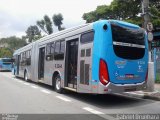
[{"xmin": 52, "ymin": 13, "xmax": 64, "ymax": 31}]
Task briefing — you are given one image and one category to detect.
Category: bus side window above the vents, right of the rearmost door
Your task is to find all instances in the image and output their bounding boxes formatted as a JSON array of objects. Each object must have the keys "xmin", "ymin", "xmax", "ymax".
[{"xmin": 80, "ymin": 31, "xmax": 94, "ymax": 43}]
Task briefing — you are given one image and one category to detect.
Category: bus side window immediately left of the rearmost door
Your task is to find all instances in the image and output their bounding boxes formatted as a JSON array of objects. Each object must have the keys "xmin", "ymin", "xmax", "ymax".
[{"xmin": 54, "ymin": 40, "xmax": 65, "ymax": 60}]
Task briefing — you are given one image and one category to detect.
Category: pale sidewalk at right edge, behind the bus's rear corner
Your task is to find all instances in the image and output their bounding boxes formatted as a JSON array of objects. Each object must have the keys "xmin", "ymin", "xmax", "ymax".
[{"xmin": 125, "ymin": 84, "xmax": 160, "ymax": 101}]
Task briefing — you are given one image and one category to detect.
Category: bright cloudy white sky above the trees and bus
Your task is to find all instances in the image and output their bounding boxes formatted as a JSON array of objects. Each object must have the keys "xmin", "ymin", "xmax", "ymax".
[{"xmin": 0, "ymin": 0, "xmax": 112, "ymax": 38}]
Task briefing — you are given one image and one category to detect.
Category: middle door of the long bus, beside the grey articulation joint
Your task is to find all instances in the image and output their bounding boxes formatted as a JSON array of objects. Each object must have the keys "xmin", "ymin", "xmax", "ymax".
[{"xmin": 38, "ymin": 47, "xmax": 45, "ymax": 80}]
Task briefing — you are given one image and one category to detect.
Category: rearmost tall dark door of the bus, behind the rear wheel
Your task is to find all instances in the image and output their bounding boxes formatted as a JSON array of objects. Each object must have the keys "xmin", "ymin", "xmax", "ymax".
[{"xmin": 66, "ymin": 38, "xmax": 78, "ymax": 89}]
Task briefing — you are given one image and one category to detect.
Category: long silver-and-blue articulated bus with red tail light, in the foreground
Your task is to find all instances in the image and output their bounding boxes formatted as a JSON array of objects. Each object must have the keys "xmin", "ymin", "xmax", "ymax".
[{"xmin": 14, "ymin": 20, "xmax": 148, "ymax": 94}]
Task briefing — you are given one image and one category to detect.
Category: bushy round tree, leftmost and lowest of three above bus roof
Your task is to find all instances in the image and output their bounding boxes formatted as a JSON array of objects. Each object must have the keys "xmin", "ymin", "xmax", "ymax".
[{"xmin": 26, "ymin": 25, "xmax": 41, "ymax": 42}]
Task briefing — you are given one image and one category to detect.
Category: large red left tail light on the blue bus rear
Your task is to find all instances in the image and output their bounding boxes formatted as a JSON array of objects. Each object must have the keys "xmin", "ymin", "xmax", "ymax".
[{"xmin": 99, "ymin": 59, "xmax": 109, "ymax": 85}]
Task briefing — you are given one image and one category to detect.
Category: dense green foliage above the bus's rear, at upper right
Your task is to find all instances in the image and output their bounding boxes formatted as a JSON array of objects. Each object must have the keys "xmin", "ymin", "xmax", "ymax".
[{"xmin": 82, "ymin": 0, "xmax": 160, "ymax": 25}]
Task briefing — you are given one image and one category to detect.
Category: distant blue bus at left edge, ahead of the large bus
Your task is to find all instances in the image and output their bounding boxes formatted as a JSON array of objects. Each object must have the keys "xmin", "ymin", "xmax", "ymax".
[{"xmin": 0, "ymin": 58, "xmax": 13, "ymax": 71}]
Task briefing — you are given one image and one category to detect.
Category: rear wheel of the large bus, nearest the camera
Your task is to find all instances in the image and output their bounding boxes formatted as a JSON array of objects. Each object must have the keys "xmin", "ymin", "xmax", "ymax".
[{"xmin": 54, "ymin": 74, "xmax": 63, "ymax": 93}]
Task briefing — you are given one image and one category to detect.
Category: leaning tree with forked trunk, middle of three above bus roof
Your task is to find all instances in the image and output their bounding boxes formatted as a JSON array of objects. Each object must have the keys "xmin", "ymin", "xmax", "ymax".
[{"xmin": 37, "ymin": 15, "xmax": 53, "ymax": 34}]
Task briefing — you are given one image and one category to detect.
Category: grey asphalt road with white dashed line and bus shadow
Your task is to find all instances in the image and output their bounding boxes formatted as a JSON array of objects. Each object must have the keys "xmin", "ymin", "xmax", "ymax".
[{"xmin": 0, "ymin": 72, "xmax": 160, "ymax": 120}]
